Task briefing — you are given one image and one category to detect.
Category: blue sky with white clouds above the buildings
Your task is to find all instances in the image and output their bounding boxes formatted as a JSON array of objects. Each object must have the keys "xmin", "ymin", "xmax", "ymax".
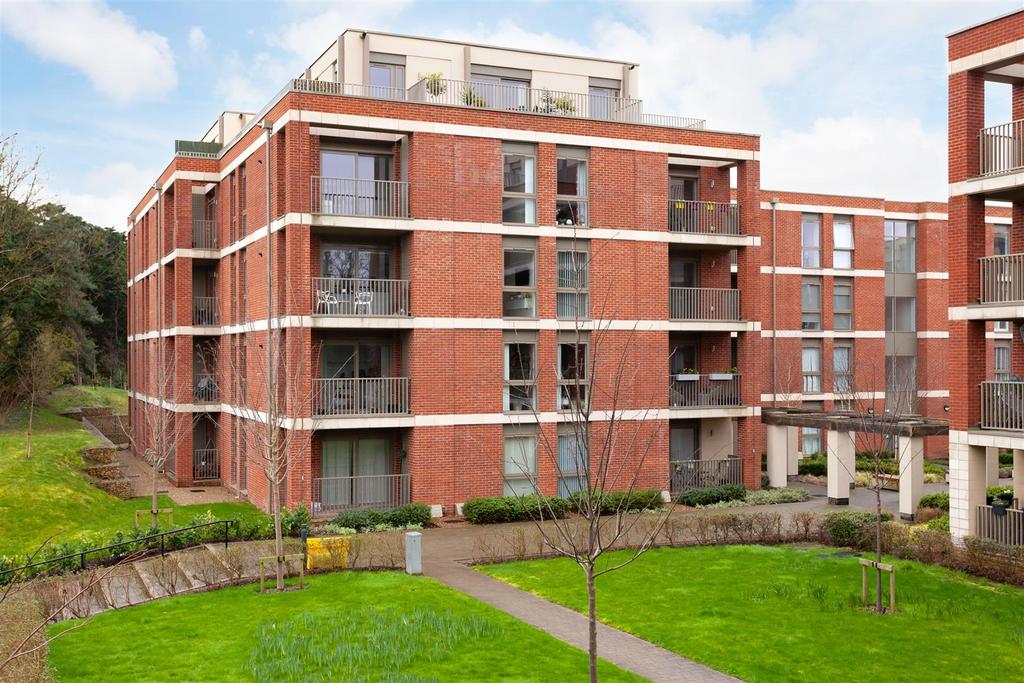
[{"xmin": 0, "ymin": 0, "xmax": 1024, "ymax": 228}]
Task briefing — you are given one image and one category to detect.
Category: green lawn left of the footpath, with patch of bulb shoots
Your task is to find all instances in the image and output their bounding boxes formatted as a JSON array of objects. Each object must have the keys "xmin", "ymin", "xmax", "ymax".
[{"xmin": 49, "ymin": 572, "xmax": 640, "ymax": 681}]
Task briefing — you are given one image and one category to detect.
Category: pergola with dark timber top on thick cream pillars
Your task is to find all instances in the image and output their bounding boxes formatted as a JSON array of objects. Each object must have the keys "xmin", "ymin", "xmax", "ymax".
[{"xmin": 761, "ymin": 408, "xmax": 949, "ymax": 520}]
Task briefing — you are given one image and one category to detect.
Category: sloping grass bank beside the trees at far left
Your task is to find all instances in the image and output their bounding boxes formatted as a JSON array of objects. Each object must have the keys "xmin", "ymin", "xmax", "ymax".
[{"xmin": 0, "ymin": 403, "xmax": 262, "ymax": 555}]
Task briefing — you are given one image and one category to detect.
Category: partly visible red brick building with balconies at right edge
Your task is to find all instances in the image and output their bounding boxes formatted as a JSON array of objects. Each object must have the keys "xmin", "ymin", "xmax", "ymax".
[{"xmin": 948, "ymin": 11, "xmax": 1024, "ymax": 543}]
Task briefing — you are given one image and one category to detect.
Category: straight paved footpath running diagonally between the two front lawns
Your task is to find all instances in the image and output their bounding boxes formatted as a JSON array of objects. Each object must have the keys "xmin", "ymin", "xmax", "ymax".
[{"xmin": 423, "ymin": 527, "xmax": 739, "ymax": 682}]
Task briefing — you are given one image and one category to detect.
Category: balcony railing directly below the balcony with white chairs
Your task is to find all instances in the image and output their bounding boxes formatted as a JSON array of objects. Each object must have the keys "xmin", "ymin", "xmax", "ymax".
[{"xmin": 313, "ymin": 377, "xmax": 409, "ymax": 418}]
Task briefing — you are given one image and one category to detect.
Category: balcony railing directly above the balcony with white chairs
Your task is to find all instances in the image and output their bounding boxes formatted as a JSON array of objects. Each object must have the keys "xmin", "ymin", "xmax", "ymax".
[{"xmin": 309, "ymin": 175, "xmax": 409, "ymax": 218}]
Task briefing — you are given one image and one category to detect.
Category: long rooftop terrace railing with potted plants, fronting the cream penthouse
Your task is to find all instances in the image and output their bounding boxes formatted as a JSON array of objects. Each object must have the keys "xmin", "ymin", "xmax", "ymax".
[{"xmin": 291, "ymin": 78, "xmax": 705, "ymax": 130}]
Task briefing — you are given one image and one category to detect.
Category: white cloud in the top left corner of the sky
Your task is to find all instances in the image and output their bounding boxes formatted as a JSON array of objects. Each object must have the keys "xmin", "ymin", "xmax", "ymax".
[{"xmin": 2, "ymin": 2, "xmax": 177, "ymax": 103}]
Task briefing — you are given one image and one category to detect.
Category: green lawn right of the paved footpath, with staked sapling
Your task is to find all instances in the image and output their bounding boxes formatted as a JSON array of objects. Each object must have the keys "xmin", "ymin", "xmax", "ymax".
[{"xmin": 480, "ymin": 546, "xmax": 1024, "ymax": 683}]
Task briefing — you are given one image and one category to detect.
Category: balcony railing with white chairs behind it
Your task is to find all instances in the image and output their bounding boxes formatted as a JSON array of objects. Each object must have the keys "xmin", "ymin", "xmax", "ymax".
[{"xmin": 312, "ymin": 278, "xmax": 410, "ymax": 317}]
